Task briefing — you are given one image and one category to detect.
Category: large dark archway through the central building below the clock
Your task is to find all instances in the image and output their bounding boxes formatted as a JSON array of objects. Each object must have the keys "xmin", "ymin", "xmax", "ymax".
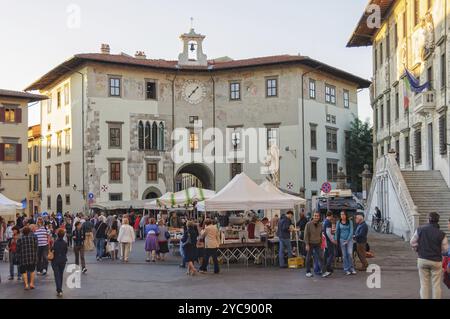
[{"xmin": 175, "ymin": 163, "xmax": 214, "ymax": 191}]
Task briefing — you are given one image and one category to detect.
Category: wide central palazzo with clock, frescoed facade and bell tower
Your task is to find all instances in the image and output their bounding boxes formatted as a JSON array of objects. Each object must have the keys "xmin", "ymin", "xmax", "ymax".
[{"xmin": 28, "ymin": 30, "xmax": 370, "ymax": 211}]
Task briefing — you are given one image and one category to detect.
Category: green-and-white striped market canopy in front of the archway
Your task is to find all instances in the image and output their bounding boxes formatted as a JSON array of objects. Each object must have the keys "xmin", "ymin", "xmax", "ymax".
[{"xmin": 145, "ymin": 187, "xmax": 216, "ymax": 209}]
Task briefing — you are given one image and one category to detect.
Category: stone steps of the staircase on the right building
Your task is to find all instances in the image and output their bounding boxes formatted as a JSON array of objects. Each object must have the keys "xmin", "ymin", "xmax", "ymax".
[{"xmin": 402, "ymin": 171, "xmax": 450, "ymax": 238}]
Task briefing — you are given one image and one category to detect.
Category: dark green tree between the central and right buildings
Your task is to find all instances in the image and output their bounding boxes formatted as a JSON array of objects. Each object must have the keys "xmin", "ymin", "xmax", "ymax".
[{"xmin": 345, "ymin": 117, "xmax": 373, "ymax": 192}]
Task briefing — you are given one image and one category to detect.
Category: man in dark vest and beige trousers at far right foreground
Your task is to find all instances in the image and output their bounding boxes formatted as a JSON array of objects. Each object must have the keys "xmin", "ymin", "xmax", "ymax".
[{"xmin": 410, "ymin": 212, "xmax": 448, "ymax": 299}]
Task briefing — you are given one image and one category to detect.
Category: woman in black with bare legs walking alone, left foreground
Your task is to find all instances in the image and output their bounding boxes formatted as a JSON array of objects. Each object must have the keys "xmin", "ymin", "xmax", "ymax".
[{"xmin": 48, "ymin": 228, "xmax": 67, "ymax": 297}]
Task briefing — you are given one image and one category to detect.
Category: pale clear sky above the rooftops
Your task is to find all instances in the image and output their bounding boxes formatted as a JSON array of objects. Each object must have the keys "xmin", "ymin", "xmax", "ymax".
[{"xmin": 0, "ymin": 0, "xmax": 372, "ymax": 125}]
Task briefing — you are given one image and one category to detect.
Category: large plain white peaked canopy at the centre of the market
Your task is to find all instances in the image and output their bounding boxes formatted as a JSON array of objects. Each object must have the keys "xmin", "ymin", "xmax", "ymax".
[{"xmin": 197, "ymin": 173, "xmax": 304, "ymax": 211}]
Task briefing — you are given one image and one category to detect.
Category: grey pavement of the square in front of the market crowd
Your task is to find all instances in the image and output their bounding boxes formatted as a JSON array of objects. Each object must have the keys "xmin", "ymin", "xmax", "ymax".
[{"xmin": 0, "ymin": 233, "xmax": 450, "ymax": 299}]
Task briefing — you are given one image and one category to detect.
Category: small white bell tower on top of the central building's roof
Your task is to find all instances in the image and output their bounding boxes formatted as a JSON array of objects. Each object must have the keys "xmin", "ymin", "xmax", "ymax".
[{"xmin": 178, "ymin": 19, "xmax": 208, "ymax": 67}]
